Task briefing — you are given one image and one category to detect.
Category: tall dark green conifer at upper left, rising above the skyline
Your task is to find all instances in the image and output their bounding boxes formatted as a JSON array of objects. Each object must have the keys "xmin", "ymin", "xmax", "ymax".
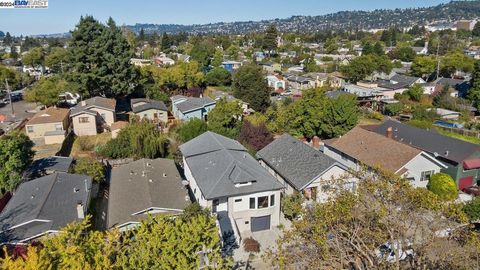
[{"xmin": 68, "ymin": 16, "xmax": 137, "ymax": 97}]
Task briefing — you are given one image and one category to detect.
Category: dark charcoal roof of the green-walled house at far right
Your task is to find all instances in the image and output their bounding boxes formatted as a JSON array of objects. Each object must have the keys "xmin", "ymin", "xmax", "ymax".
[{"xmin": 374, "ymin": 120, "xmax": 480, "ymax": 164}]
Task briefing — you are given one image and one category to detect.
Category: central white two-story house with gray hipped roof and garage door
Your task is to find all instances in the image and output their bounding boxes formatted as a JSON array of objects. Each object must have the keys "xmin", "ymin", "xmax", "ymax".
[{"xmin": 180, "ymin": 131, "xmax": 283, "ymax": 241}]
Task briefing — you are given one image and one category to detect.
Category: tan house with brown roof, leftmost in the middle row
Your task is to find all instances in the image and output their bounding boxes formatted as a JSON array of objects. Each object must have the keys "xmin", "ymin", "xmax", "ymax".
[{"xmin": 25, "ymin": 107, "xmax": 70, "ymax": 144}]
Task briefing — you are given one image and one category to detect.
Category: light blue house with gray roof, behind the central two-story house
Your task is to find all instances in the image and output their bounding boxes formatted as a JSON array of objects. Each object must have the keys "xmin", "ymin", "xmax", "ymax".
[{"xmin": 170, "ymin": 95, "xmax": 216, "ymax": 121}]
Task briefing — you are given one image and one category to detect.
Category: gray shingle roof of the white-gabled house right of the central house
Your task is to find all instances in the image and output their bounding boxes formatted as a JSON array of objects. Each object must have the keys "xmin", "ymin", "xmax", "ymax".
[{"xmin": 257, "ymin": 133, "xmax": 343, "ymax": 190}]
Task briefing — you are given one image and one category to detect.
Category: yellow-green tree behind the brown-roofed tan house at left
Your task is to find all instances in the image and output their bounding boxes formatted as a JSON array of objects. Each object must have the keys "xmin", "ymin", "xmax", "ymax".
[{"xmin": 24, "ymin": 76, "xmax": 71, "ymax": 107}]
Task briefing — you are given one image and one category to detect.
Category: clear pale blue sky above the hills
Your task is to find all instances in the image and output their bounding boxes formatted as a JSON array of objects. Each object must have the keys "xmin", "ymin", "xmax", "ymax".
[{"xmin": 0, "ymin": 0, "xmax": 448, "ymax": 35}]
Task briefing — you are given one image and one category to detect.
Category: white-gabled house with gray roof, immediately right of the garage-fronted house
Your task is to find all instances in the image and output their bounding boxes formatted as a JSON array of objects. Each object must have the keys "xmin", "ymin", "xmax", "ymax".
[{"xmin": 257, "ymin": 133, "xmax": 356, "ymax": 202}]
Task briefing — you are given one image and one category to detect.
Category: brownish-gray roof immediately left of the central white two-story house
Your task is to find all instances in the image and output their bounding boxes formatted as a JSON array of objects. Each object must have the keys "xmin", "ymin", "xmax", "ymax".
[{"xmin": 107, "ymin": 158, "xmax": 190, "ymax": 228}]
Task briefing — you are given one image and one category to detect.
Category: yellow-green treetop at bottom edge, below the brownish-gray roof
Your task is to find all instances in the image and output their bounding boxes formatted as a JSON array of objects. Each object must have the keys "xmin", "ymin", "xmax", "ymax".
[{"xmin": 115, "ymin": 214, "xmax": 233, "ymax": 269}]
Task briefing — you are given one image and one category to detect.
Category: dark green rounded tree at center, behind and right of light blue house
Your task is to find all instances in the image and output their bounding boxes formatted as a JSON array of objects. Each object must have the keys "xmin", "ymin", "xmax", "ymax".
[{"xmin": 232, "ymin": 64, "xmax": 270, "ymax": 112}]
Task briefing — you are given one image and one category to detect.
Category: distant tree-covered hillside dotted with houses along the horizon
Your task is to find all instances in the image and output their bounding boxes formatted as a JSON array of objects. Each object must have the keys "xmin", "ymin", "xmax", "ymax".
[{"xmin": 129, "ymin": 1, "xmax": 480, "ymax": 34}]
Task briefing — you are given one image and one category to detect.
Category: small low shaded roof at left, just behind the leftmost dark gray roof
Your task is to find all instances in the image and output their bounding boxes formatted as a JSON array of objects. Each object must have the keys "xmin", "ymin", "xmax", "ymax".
[{"xmin": 25, "ymin": 156, "xmax": 73, "ymax": 177}]
